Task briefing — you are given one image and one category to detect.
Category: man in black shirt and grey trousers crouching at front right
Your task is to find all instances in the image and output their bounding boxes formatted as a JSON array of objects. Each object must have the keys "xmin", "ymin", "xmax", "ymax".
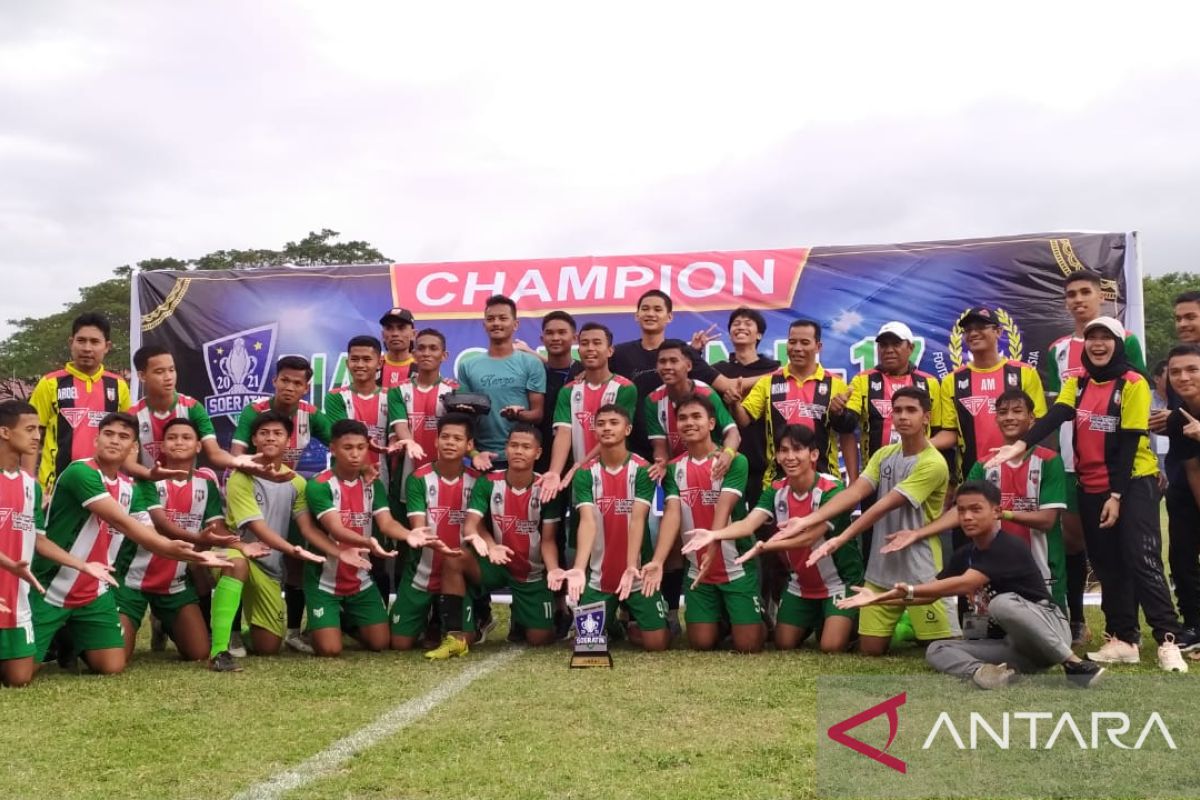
[{"xmin": 838, "ymin": 481, "xmax": 1104, "ymax": 688}]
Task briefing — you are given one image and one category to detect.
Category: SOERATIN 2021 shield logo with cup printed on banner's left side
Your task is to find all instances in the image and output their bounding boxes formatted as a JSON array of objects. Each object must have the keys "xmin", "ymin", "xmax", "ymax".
[{"xmin": 200, "ymin": 323, "xmax": 278, "ymax": 417}]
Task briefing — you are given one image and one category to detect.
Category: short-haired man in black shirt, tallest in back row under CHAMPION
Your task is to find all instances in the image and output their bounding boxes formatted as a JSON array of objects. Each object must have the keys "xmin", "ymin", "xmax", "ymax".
[{"xmin": 608, "ymin": 289, "xmax": 733, "ymax": 461}]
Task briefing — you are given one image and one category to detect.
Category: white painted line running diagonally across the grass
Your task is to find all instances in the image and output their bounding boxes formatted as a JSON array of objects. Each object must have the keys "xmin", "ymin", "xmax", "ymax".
[{"xmin": 234, "ymin": 648, "xmax": 524, "ymax": 800}]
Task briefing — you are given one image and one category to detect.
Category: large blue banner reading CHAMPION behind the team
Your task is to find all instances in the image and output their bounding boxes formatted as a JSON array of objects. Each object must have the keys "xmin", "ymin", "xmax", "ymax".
[{"xmin": 131, "ymin": 227, "xmax": 1142, "ymax": 468}]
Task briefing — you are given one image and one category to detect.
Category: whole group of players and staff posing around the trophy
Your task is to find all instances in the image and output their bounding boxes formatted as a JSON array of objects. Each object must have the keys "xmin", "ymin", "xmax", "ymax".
[{"xmin": 0, "ymin": 271, "xmax": 1200, "ymax": 688}]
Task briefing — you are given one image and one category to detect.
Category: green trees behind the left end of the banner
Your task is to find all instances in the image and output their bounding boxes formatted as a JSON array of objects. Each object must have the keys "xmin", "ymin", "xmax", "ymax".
[{"xmin": 0, "ymin": 228, "xmax": 390, "ymax": 381}]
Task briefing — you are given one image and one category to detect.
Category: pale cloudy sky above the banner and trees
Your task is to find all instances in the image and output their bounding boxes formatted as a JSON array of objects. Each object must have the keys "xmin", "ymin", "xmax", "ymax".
[{"xmin": 0, "ymin": 0, "xmax": 1200, "ymax": 336}]
